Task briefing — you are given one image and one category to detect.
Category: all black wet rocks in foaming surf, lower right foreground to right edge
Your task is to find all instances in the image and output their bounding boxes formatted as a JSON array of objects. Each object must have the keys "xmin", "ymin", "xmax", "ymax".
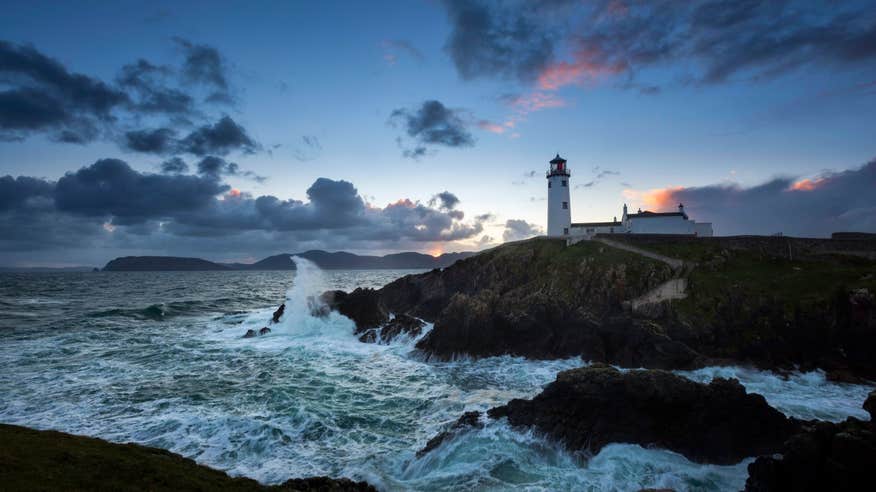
[{"xmin": 417, "ymin": 364, "xmax": 876, "ymax": 492}]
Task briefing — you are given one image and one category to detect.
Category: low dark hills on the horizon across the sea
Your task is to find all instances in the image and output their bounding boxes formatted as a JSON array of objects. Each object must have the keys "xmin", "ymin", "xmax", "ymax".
[{"xmin": 103, "ymin": 250, "xmax": 475, "ymax": 272}]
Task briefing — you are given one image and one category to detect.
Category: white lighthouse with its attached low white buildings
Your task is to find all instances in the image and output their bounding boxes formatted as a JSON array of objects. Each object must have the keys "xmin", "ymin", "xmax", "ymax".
[{"xmin": 547, "ymin": 154, "xmax": 712, "ymax": 238}]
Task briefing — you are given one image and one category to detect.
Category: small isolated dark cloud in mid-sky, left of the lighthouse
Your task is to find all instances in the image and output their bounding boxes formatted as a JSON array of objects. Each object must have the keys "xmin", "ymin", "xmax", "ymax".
[{"xmin": 390, "ymin": 100, "xmax": 475, "ymax": 157}]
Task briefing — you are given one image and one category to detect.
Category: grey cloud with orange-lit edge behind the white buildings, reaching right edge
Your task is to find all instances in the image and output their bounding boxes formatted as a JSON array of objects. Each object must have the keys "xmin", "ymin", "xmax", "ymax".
[{"xmin": 626, "ymin": 160, "xmax": 876, "ymax": 237}]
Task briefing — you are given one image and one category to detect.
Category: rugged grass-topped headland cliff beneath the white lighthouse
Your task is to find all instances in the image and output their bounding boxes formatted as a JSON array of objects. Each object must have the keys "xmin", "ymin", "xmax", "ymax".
[{"xmin": 328, "ymin": 236, "xmax": 876, "ymax": 379}]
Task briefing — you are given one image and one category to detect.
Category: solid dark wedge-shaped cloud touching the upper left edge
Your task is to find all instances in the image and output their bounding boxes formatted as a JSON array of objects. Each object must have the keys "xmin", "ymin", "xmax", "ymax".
[{"xmin": 0, "ymin": 41, "xmax": 128, "ymax": 143}]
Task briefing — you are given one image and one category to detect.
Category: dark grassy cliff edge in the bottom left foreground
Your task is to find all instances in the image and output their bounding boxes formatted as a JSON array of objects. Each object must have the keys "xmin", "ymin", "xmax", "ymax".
[{"xmin": 0, "ymin": 424, "xmax": 376, "ymax": 492}]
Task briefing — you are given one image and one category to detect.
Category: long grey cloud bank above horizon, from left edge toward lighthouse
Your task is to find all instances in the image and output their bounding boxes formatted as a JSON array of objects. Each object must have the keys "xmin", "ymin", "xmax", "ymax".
[{"xmin": 0, "ymin": 160, "xmax": 483, "ymax": 263}]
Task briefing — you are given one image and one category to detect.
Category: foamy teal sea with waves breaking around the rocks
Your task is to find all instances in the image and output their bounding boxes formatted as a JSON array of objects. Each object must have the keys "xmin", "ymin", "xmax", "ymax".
[{"xmin": 0, "ymin": 260, "xmax": 872, "ymax": 490}]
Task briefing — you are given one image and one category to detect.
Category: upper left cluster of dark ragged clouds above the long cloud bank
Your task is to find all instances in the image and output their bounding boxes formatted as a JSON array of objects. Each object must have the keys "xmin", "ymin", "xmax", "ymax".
[{"xmin": 0, "ymin": 39, "xmax": 260, "ymax": 151}]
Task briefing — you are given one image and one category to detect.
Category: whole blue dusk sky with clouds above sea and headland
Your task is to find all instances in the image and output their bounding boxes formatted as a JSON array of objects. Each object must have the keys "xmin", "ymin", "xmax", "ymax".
[{"xmin": 0, "ymin": 0, "xmax": 876, "ymax": 266}]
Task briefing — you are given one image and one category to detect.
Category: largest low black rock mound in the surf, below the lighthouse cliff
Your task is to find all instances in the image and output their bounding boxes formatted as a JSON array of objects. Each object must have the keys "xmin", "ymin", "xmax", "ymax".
[{"xmin": 488, "ymin": 364, "xmax": 799, "ymax": 464}]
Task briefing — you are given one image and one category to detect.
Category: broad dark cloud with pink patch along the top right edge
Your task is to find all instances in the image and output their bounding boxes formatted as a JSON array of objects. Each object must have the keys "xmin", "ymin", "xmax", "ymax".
[{"xmin": 443, "ymin": 0, "xmax": 876, "ymax": 88}]
